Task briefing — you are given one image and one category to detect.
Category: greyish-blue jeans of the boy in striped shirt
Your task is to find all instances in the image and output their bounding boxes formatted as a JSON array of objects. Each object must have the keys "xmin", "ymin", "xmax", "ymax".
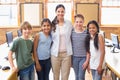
[{"xmin": 72, "ymin": 56, "xmax": 86, "ymax": 80}]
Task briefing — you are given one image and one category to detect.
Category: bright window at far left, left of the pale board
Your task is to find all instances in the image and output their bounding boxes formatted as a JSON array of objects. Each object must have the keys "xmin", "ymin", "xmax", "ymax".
[{"xmin": 0, "ymin": 0, "xmax": 18, "ymax": 27}]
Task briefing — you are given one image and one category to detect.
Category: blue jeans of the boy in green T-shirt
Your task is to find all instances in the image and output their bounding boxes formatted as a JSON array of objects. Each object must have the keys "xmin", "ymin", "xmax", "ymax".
[{"xmin": 19, "ymin": 64, "xmax": 35, "ymax": 80}]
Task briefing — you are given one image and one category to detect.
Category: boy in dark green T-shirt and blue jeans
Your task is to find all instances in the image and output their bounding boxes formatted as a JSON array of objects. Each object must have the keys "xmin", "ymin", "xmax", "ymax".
[{"xmin": 8, "ymin": 22, "xmax": 34, "ymax": 80}]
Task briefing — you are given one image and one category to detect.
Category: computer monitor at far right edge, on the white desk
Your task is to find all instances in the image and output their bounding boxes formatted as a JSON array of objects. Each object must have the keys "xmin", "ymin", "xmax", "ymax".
[{"xmin": 111, "ymin": 33, "xmax": 120, "ymax": 53}]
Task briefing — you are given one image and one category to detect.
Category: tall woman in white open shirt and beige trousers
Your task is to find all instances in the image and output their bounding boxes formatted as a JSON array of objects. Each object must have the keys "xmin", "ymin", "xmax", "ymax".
[{"xmin": 51, "ymin": 4, "xmax": 72, "ymax": 80}]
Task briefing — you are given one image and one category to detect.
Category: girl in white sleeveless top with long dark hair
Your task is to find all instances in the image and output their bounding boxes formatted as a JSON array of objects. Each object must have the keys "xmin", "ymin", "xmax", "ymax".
[{"xmin": 86, "ymin": 20, "xmax": 105, "ymax": 80}]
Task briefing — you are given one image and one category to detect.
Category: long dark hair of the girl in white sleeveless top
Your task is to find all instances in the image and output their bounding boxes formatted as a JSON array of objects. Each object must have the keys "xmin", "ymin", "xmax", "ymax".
[{"xmin": 86, "ymin": 20, "xmax": 99, "ymax": 51}]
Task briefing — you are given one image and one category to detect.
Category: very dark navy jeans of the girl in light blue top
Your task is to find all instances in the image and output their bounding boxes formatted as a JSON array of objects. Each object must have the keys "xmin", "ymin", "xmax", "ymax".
[{"xmin": 37, "ymin": 58, "xmax": 51, "ymax": 80}]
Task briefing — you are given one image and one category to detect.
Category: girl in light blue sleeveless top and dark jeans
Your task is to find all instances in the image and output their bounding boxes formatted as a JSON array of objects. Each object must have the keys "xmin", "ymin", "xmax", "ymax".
[{"xmin": 34, "ymin": 18, "xmax": 52, "ymax": 80}]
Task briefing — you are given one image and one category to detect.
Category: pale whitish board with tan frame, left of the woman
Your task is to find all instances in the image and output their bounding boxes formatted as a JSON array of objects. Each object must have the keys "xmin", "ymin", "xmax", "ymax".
[{"xmin": 20, "ymin": 3, "xmax": 44, "ymax": 26}]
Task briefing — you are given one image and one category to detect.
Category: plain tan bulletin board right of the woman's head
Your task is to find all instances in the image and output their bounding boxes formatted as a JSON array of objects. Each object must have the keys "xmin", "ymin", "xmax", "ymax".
[{"xmin": 76, "ymin": 3, "xmax": 99, "ymax": 26}]
